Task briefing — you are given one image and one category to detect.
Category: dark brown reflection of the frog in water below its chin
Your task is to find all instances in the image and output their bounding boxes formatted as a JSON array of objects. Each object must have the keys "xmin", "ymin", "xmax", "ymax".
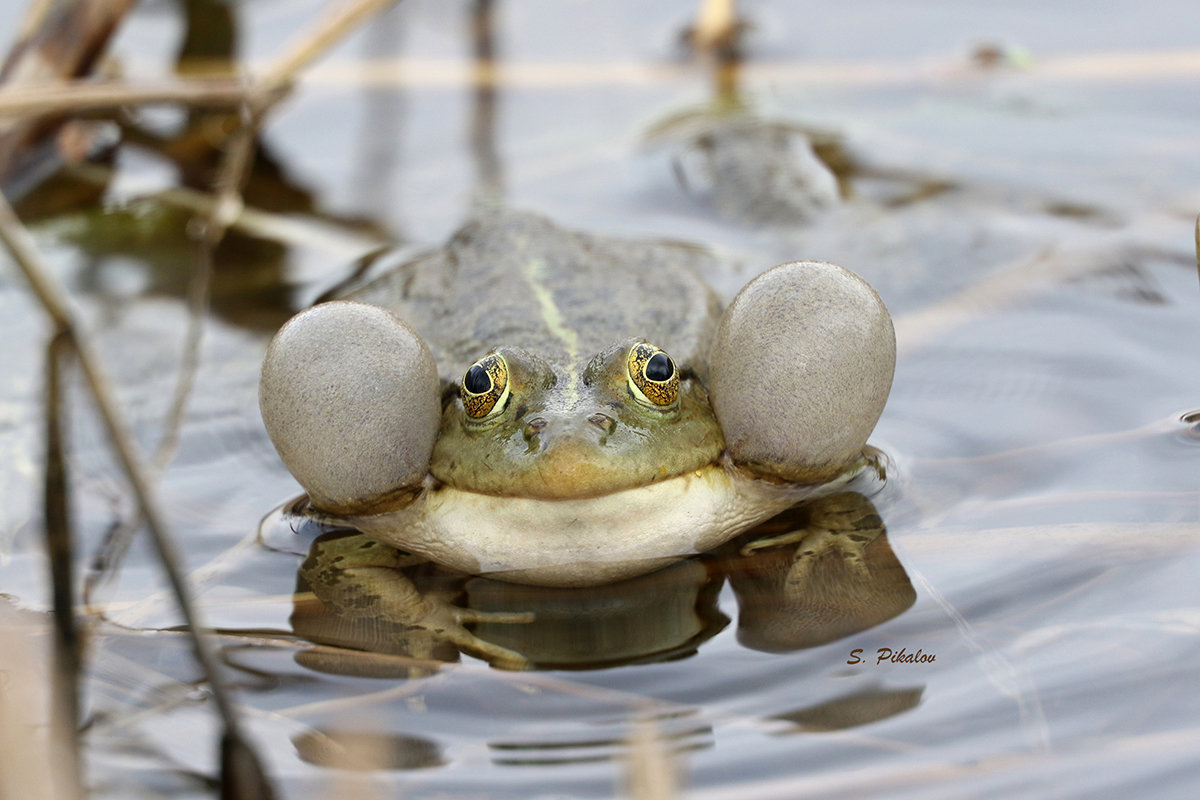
[{"xmin": 290, "ymin": 491, "xmax": 916, "ymax": 678}]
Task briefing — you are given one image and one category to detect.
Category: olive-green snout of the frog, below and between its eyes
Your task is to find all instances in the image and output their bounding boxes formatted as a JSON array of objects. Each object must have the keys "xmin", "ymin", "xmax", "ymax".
[{"xmin": 430, "ymin": 345, "xmax": 725, "ymax": 499}]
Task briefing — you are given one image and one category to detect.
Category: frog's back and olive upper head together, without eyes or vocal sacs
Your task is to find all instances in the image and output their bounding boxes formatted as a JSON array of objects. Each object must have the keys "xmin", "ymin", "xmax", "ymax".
[{"xmin": 347, "ymin": 212, "xmax": 725, "ymax": 498}]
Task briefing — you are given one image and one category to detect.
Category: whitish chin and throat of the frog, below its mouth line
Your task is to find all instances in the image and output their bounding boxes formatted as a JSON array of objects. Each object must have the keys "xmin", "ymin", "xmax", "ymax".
[{"xmin": 348, "ymin": 463, "xmax": 842, "ymax": 587}]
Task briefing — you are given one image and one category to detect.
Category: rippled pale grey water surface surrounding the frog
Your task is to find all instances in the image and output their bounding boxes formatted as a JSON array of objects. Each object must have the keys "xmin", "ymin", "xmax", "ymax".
[{"xmin": 0, "ymin": 0, "xmax": 1200, "ymax": 798}]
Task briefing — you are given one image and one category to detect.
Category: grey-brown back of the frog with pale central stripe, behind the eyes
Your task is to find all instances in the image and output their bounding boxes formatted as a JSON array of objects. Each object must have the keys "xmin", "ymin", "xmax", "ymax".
[{"xmin": 349, "ymin": 211, "xmax": 720, "ymax": 380}]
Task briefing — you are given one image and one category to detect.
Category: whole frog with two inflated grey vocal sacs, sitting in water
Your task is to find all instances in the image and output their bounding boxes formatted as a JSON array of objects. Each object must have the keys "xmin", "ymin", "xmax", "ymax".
[{"xmin": 259, "ymin": 211, "xmax": 895, "ymax": 655}]
